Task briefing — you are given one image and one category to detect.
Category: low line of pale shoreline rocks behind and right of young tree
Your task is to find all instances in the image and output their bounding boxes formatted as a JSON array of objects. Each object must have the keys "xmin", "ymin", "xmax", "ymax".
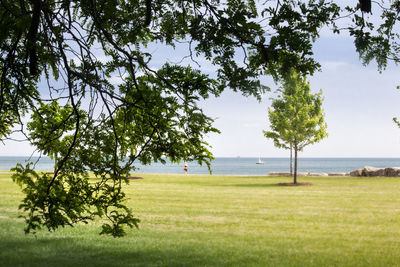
[{"xmin": 268, "ymin": 166, "xmax": 400, "ymax": 177}]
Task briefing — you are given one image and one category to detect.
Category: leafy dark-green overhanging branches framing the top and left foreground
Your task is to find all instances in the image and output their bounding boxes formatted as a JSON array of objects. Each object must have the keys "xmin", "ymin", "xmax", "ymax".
[{"xmin": 0, "ymin": 0, "xmax": 399, "ymax": 236}]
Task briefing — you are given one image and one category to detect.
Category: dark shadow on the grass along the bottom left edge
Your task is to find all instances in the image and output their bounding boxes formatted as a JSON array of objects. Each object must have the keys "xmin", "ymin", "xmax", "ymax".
[{"xmin": 0, "ymin": 236, "xmax": 234, "ymax": 266}]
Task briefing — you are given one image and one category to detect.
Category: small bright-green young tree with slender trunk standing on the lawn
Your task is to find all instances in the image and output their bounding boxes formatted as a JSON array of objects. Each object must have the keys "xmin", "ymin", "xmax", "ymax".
[{"xmin": 264, "ymin": 70, "xmax": 327, "ymax": 184}]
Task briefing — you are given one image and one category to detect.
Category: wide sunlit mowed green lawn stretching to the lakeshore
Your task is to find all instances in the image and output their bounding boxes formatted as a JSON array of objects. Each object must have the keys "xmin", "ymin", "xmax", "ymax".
[{"xmin": 0, "ymin": 172, "xmax": 400, "ymax": 266}]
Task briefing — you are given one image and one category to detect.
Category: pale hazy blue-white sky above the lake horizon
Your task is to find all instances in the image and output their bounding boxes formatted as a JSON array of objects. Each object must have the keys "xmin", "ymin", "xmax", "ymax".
[{"xmin": 0, "ymin": 21, "xmax": 400, "ymax": 158}]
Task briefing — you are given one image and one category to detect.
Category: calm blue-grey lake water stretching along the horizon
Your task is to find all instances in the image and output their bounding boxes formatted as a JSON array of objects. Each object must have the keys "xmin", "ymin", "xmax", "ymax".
[{"xmin": 0, "ymin": 156, "xmax": 400, "ymax": 175}]
